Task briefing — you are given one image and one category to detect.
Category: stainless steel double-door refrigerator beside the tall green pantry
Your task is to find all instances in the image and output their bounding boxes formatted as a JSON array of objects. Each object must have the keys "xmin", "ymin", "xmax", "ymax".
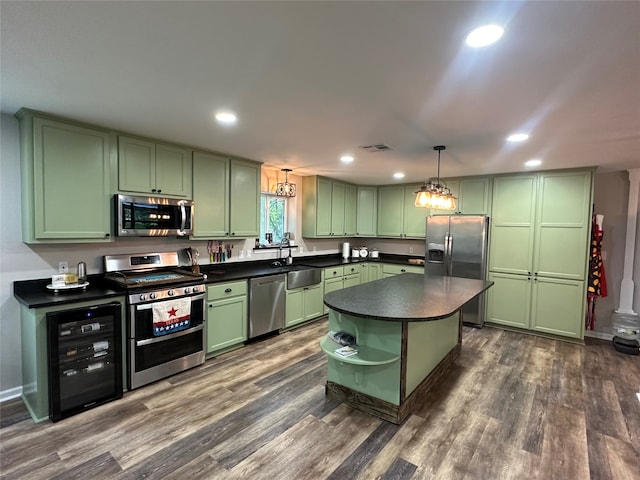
[{"xmin": 424, "ymin": 215, "xmax": 489, "ymax": 328}]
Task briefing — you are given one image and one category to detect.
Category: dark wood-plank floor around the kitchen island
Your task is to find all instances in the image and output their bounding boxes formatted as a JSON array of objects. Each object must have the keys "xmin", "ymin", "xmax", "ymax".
[{"xmin": 0, "ymin": 320, "xmax": 640, "ymax": 480}]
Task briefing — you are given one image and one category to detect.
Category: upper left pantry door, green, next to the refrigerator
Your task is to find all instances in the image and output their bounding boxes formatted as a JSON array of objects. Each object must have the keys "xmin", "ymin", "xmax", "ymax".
[{"xmin": 489, "ymin": 175, "xmax": 537, "ymax": 275}]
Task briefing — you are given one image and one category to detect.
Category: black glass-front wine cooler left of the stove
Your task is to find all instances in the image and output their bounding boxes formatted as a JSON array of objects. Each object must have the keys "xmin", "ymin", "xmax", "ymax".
[{"xmin": 47, "ymin": 302, "xmax": 122, "ymax": 422}]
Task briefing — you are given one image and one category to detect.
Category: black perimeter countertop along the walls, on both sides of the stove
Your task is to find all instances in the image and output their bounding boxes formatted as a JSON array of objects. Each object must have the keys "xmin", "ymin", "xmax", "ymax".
[{"xmin": 13, "ymin": 254, "xmax": 424, "ymax": 308}]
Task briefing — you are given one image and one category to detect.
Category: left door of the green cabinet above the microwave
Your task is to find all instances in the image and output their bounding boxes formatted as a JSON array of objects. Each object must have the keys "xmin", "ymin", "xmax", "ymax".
[{"xmin": 118, "ymin": 136, "xmax": 157, "ymax": 194}]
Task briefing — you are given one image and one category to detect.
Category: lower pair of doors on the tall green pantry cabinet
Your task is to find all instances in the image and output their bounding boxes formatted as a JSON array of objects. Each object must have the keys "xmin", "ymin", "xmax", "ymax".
[{"xmin": 487, "ymin": 273, "xmax": 585, "ymax": 339}]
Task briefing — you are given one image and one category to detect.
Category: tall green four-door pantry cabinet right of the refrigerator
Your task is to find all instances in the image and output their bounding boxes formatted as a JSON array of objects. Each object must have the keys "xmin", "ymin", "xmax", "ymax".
[{"xmin": 487, "ymin": 170, "xmax": 593, "ymax": 339}]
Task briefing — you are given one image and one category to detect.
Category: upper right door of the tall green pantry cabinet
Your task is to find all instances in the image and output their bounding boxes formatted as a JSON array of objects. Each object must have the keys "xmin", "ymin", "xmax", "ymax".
[{"xmin": 533, "ymin": 171, "xmax": 591, "ymax": 280}]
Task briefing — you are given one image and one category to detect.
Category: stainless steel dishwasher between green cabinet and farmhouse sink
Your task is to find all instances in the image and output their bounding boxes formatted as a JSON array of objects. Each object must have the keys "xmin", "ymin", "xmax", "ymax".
[{"xmin": 249, "ymin": 274, "xmax": 286, "ymax": 338}]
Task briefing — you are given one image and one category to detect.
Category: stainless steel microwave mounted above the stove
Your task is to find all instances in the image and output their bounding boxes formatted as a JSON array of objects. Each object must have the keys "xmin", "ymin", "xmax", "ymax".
[{"xmin": 114, "ymin": 195, "xmax": 194, "ymax": 237}]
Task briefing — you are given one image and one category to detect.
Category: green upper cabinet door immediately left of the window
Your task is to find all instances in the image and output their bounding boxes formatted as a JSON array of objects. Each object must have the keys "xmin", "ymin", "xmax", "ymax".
[{"xmin": 229, "ymin": 159, "xmax": 260, "ymax": 238}]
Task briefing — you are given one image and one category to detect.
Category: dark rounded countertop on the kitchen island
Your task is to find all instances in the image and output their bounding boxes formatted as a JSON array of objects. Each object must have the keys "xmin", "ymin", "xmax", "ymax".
[{"xmin": 324, "ymin": 273, "xmax": 493, "ymax": 321}]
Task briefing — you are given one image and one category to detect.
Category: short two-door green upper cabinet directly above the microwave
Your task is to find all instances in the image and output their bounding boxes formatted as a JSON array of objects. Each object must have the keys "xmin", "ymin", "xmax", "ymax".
[{"xmin": 118, "ymin": 136, "xmax": 192, "ymax": 198}]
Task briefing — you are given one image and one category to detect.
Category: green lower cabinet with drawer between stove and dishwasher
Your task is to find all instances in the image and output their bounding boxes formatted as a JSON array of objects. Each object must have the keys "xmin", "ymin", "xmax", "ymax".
[{"xmin": 207, "ymin": 280, "xmax": 248, "ymax": 354}]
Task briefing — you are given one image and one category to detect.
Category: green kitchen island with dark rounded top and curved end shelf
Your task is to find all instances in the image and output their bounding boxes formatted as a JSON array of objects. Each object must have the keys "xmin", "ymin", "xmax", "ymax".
[{"xmin": 320, "ymin": 273, "xmax": 493, "ymax": 424}]
